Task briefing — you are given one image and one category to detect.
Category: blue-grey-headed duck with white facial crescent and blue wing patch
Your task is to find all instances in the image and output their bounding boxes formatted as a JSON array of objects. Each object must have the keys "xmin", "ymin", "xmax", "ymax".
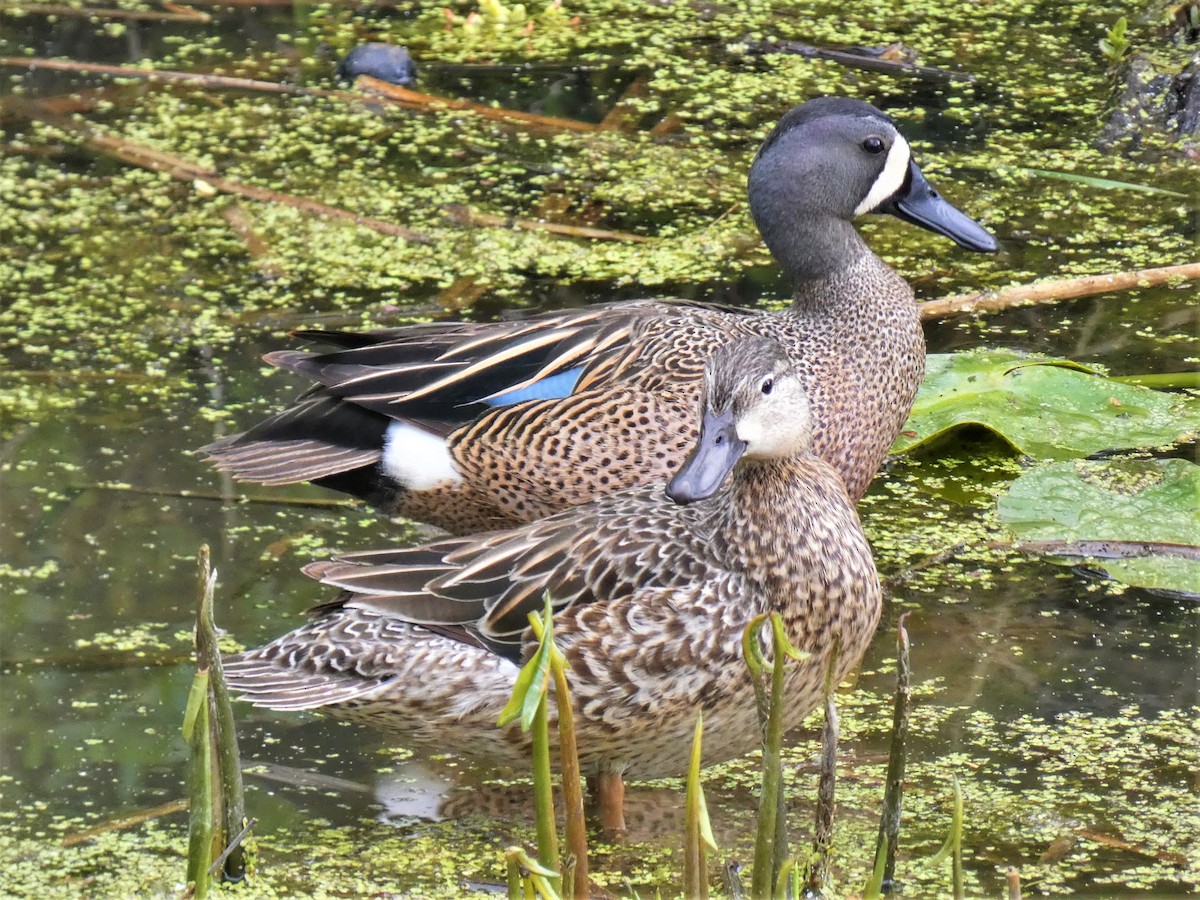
[{"xmin": 202, "ymin": 97, "xmax": 997, "ymax": 534}]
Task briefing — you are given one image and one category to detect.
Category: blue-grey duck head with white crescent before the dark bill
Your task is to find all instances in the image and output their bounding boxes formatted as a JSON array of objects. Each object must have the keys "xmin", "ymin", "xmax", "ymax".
[{"xmin": 749, "ymin": 97, "xmax": 997, "ymax": 277}]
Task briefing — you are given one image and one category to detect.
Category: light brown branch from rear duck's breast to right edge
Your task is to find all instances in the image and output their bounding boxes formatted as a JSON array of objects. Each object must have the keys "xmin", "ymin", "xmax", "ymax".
[{"xmin": 920, "ymin": 263, "xmax": 1200, "ymax": 319}]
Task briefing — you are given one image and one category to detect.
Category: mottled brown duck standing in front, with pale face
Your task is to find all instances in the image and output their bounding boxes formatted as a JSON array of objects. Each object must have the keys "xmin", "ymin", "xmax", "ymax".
[{"xmin": 223, "ymin": 336, "xmax": 882, "ymax": 833}]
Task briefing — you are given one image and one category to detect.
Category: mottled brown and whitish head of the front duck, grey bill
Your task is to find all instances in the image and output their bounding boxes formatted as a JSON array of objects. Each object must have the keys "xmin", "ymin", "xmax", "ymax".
[{"xmin": 667, "ymin": 337, "xmax": 812, "ymax": 505}]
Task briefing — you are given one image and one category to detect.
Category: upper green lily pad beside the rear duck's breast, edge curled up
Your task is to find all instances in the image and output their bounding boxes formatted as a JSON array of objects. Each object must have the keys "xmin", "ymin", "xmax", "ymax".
[{"xmin": 892, "ymin": 350, "xmax": 1200, "ymax": 460}]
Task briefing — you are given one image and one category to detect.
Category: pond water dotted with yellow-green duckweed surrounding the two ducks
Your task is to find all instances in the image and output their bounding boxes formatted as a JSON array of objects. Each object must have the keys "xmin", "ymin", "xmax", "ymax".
[{"xmin": 0, "ymin": 2, "xmax": 1200, "ymax": 896}]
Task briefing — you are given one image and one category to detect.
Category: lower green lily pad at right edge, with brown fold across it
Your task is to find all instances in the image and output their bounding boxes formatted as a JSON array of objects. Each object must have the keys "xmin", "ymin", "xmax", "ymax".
[{"xmin": 997, "ymin": 460, "xmax": 1200, "ymax": 596}]
